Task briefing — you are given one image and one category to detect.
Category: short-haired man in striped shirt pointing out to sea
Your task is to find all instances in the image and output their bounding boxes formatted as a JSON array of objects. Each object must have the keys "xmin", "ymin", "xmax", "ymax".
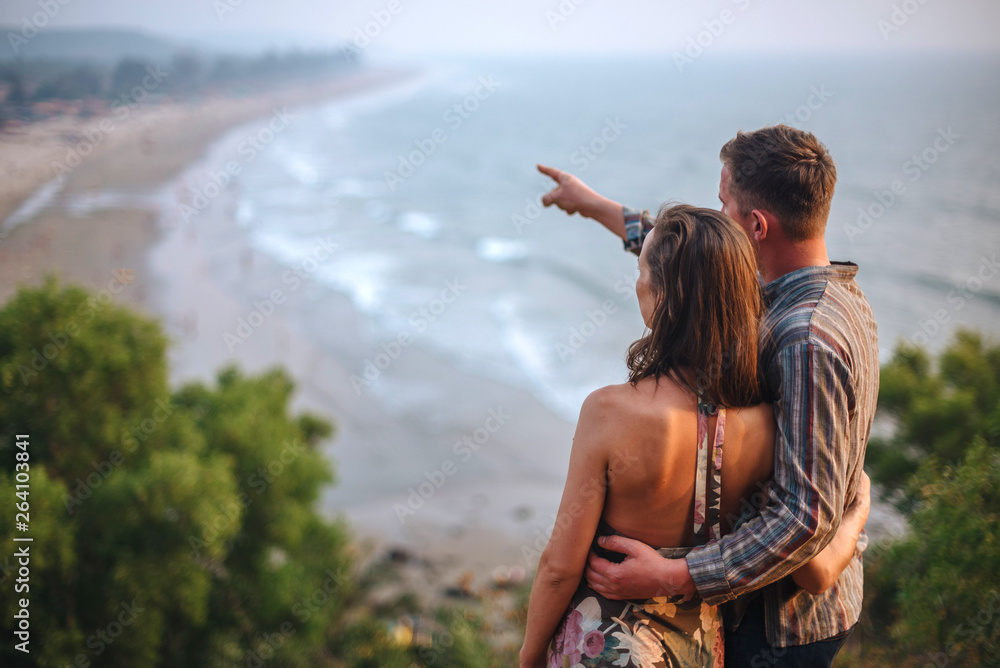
[{"xmin": 539, "ymin": 125, "xmax": 879, "ymax": 666}]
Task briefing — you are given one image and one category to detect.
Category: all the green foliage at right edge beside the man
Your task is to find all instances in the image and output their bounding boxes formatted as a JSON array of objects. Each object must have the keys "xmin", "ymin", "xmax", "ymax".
[{"xmin": 840, "ymin": 331, "xmax": 1000, "ymax": 667}]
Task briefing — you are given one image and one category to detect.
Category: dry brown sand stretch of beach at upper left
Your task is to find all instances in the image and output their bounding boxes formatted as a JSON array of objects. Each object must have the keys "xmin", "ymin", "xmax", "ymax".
[{"xmin": 0, "ymin": 70, "xmax": 407, "ymax": 308}]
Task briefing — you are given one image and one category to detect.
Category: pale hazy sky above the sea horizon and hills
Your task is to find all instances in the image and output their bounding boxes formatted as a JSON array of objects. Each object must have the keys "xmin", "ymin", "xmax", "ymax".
[{"xmin": 0, "ymin": 0, "xmax": 1000, "ymax": 52}]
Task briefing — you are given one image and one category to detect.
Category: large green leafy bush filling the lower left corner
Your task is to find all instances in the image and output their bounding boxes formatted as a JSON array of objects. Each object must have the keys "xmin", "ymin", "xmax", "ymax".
[{"xmin": 0, "ymin": 280, "xmax": 354, "ymax": 666}]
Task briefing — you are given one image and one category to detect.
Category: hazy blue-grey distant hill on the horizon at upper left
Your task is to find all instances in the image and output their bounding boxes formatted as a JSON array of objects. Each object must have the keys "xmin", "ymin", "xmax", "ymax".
[{"xmin": 0, "ymin": 25, "xmax": 183, "ymax": 61}]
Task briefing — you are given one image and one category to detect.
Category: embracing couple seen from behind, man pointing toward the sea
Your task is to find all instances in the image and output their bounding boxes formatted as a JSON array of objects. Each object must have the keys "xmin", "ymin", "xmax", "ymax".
[{"xmin": 521, "ymin": 125, "xmax": 879, "ymax": 668}]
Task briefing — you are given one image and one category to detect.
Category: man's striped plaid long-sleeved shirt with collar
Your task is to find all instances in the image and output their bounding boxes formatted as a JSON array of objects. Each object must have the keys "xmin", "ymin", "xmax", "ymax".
[{"xmin": 625, "ymin": 209, "xmax": 879, "ymax": 647}]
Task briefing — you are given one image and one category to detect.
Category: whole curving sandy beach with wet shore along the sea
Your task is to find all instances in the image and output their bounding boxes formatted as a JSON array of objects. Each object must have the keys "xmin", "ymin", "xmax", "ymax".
[{"xmin": 0, "ymin": 62, "xmax": 573, "ymax": 603}]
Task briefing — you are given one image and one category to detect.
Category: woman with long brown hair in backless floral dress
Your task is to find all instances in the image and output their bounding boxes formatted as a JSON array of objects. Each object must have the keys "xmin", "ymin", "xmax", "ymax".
[{"xmin": 521, "ymin": 205, "xmax": 867, "ymax": 668}]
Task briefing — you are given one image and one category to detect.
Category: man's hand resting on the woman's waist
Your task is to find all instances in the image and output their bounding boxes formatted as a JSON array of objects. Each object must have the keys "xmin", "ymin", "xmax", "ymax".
[{"xmin": 584, "ymin": 536, "xmax": 697, "ymax": 601}]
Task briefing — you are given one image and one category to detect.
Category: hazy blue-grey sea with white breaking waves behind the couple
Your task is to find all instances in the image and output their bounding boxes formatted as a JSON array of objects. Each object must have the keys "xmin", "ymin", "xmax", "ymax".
[{"xmin": 211, "ymin": 54, "xmax": 1000, "ymax": 421}]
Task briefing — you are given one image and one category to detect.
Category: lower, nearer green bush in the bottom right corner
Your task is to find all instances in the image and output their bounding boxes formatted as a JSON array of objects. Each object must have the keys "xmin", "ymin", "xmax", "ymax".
[{"xmin": 866, "ymin": 439, "xmax": 1000, "ymax": 666}]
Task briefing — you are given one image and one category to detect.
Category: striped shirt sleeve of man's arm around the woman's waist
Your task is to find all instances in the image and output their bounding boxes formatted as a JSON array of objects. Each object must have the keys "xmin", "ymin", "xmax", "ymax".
[{"xmin": 687, "ymin": 343, "xmax": 867, "ymax": 605}]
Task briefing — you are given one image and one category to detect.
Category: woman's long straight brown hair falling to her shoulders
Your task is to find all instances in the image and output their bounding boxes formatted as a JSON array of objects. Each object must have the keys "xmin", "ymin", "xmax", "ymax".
[{"xmin": 627, "ymin": 204, "xmax": 764, "ymax": 407}]
